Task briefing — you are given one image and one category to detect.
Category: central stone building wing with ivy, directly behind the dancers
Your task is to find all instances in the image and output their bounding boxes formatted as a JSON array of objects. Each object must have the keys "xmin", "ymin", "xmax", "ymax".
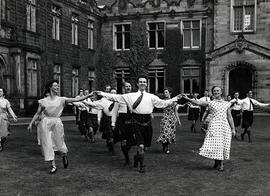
[{"xmin": 97, "ymin": 0, "xmax": 213, "ymax": 94}]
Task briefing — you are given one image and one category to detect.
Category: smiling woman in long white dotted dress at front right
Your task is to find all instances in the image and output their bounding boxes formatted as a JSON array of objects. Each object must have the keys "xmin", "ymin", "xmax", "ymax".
[{"xmin": 184, "ymin": 86, "xmax": 235, "ymax": 171}]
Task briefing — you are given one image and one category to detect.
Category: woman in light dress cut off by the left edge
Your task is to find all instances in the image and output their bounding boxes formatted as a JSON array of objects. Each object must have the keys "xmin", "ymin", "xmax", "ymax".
[{"xmin": 0, "ymin": 87, "xmax": 17, "ymax": 152}]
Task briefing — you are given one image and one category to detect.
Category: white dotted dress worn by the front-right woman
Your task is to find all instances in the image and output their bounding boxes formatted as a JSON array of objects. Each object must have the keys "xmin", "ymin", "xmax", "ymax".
[{"xmin": 199, "ymin": 100, "xmax": 232, "ymax": 160}]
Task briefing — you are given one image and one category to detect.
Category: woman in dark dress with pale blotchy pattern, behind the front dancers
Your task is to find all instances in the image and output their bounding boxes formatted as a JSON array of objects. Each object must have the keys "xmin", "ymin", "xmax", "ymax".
[{"xmin": 157, "ymin": 88, "xmax": 184, "ymax": 154}]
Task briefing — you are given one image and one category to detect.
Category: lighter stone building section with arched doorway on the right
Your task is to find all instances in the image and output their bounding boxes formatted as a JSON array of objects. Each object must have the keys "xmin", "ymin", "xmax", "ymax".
[{"xmin": 206, "ymin": 0, "xmax": 270, "ymax": 102}]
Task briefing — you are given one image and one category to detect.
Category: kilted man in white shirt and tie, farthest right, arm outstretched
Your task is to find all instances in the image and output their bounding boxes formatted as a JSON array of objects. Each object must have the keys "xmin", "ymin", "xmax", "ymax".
[{"xmin": 241, "ymin": 91, "xmax": 269, "ymax": 143}]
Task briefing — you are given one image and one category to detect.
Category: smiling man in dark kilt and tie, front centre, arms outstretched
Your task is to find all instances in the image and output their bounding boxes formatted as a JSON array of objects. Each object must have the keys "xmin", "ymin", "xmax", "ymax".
[{"xmin": 97, "ymin": 76, "xmax": 179, "ymax": 173}]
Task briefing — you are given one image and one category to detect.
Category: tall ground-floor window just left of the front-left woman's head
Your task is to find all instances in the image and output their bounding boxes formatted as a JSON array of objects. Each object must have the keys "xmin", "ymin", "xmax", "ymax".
[{"xmin": 27, "ymin": 59, "xmax": 38, "ymax": 96}]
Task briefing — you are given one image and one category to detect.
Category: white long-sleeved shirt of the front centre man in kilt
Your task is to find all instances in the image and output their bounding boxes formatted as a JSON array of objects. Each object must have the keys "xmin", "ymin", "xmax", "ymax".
[{"xmin": 101, "ymin": 91, "xmax": 178, "ymax": 114}]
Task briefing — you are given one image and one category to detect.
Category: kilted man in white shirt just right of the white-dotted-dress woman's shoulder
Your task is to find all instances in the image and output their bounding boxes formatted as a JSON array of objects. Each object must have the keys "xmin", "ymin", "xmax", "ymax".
[{"xmin": 230, "ymin": 92, "xmax": 243, "ymax": 139}]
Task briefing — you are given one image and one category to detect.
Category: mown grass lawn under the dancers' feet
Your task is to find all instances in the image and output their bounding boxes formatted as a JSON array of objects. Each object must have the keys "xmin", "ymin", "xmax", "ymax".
[{"xmin": 0, "ymin": 116, "xmax": 270, "ymax": 196}]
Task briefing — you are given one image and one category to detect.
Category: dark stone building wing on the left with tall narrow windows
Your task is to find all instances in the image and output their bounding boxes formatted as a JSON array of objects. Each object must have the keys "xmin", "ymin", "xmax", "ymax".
[{"xmin": 0, "ymin": 0, "xmax": 100, "ymax": 113}]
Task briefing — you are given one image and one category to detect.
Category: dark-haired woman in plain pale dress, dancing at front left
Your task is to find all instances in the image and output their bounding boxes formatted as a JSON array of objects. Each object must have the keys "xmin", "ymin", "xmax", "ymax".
[{"xmin": 28, "ymin": 80, "xmax": 92, "ymax": 174}]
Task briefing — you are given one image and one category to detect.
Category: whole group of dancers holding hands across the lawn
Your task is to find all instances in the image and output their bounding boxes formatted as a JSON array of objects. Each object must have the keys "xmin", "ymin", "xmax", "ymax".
[{"xmin": 0, "ymin": 75, "xmax": 269, "ymax": 174}]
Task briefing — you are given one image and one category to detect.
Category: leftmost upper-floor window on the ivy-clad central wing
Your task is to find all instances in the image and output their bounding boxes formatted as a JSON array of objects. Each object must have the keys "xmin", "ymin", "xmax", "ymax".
[{"xmin": 113, "ymin": 24, "xmax": 130, "ymax": 50}]
